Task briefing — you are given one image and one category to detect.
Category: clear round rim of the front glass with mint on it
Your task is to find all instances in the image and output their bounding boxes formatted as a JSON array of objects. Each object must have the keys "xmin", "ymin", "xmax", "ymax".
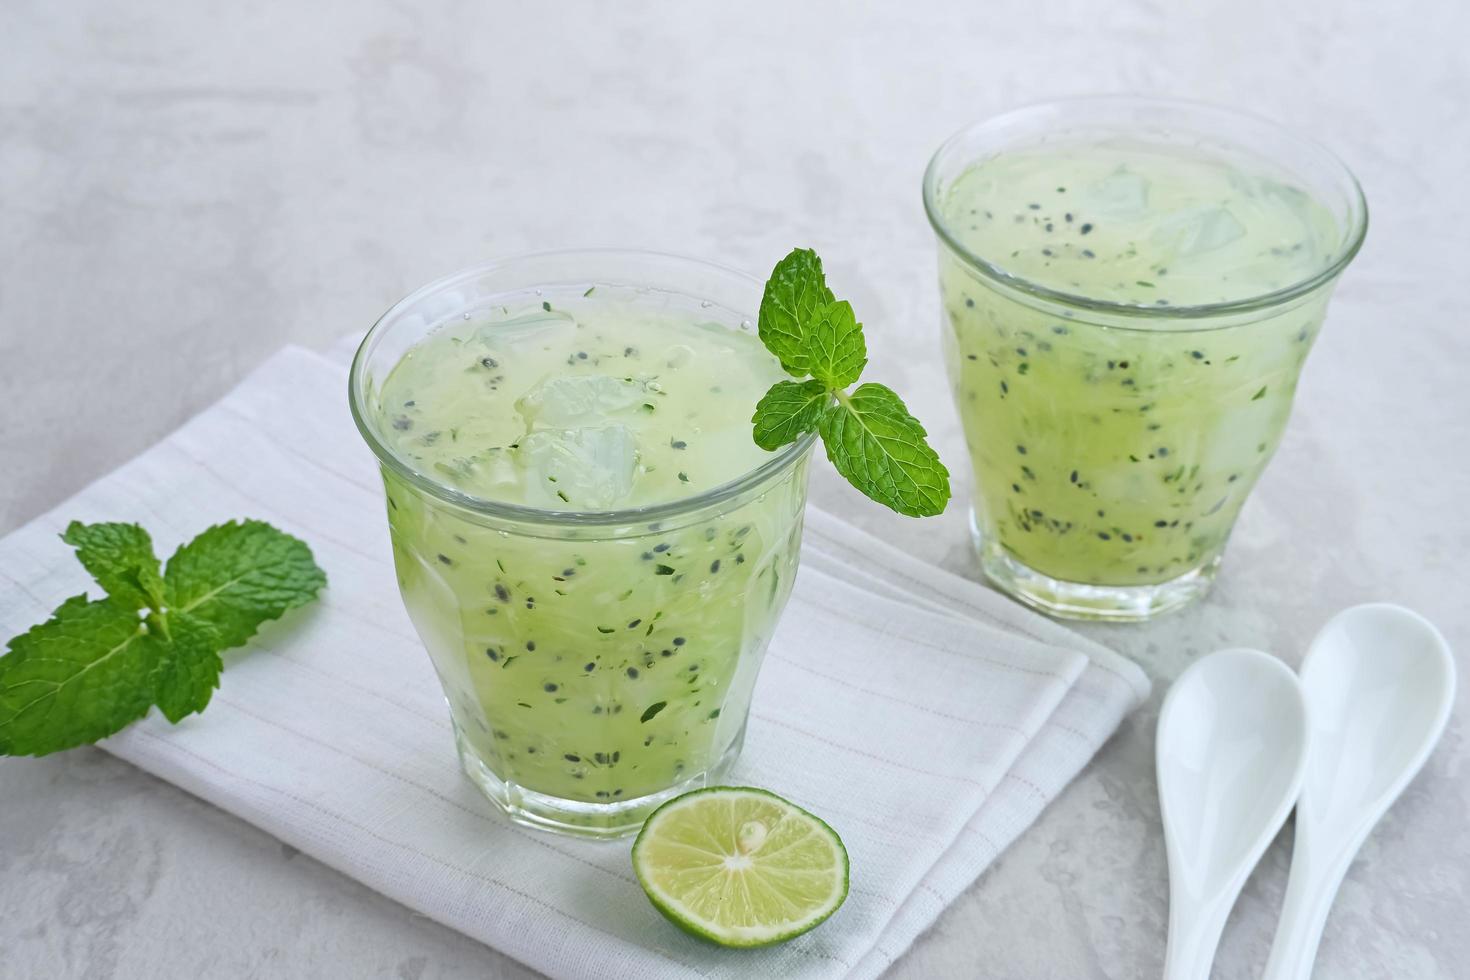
[{"xmin": 347, "ymin": 248, "xmax": 817, "ymax": 527}]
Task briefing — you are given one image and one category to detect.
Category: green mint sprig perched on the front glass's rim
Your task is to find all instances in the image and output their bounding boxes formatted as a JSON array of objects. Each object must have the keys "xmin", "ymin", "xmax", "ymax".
[{"xmin": 751, "ymin": 248, "xmax": 950, "ymax": 517}]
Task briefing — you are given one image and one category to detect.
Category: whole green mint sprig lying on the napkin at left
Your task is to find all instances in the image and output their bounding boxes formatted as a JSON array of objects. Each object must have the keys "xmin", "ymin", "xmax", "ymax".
[{"xmin": 0, "ymin": 520, "xmax": 326, "ymax": 755}]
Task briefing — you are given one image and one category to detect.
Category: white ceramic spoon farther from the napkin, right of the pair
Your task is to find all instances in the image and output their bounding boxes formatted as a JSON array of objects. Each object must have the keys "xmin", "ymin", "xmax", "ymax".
[{"xmin": 1266, "ymin": 602, "xmax": 1455, "ymax": 980}]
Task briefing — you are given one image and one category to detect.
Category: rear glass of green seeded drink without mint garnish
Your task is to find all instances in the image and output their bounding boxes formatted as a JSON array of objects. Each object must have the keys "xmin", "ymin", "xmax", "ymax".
[{"xmin": 923, "ymin": 97, "xmax": 1367, "ymax": 620}]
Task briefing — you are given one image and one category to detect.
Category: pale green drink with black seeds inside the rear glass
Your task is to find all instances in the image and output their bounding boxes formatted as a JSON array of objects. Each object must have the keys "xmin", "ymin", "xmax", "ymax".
[{"xmin": 942, "ymin": 148, "xmax": 1338, "ymax": 585}]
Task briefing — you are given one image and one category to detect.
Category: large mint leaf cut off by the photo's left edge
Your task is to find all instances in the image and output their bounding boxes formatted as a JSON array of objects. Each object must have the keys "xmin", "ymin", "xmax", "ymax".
[{"xmin": 0, "ymin": 595, "xmax": 162, "ymax": 755}]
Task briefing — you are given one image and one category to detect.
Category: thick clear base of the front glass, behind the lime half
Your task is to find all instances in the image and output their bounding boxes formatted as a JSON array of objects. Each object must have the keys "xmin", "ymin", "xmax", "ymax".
[{"xmin": 454, "ymin": 724, "xmax": 745, "ymax": 840}]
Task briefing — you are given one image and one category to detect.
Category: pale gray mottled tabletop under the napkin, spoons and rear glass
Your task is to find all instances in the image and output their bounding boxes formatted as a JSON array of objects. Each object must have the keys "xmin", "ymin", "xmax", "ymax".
[{"xmin": 0, "ymin": 0, "xmax": 1470, "ymax": 979}]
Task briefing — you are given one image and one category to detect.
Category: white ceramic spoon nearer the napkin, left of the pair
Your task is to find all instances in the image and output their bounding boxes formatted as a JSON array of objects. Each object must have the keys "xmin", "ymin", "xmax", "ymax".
[{"xmin": 1155, "ymin": 649, "xmax": 1307, "ymax": 980}]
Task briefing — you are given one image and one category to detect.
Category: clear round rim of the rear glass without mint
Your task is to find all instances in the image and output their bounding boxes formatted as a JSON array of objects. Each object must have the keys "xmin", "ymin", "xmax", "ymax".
[{"xmin": 923, "ymin": 96, "xmax": 1369, "ymax": 321}]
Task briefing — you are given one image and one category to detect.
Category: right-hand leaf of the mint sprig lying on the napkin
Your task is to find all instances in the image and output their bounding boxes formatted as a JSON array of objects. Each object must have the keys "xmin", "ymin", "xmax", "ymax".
[{"xmin": 163, "ymin": 520, "xmax": 326, "ymax": 648}]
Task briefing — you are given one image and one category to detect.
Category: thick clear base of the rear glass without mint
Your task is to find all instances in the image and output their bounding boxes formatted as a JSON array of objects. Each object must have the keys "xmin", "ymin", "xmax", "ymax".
[{"xmin": 970, "ymin": 510, "xmax": 1220, "ymax": 623}]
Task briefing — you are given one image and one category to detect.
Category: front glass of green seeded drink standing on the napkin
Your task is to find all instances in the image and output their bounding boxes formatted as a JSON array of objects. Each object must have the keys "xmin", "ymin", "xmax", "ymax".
[{"xmin": 350, "ymin": 251, "xmax": 813, "ymax": 837}]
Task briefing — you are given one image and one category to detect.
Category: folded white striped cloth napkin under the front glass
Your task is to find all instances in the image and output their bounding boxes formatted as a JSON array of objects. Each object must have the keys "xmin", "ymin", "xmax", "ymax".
[{"xmin": 0, "ymin": 348, "xmax": 1148, "ymax": 977}]
